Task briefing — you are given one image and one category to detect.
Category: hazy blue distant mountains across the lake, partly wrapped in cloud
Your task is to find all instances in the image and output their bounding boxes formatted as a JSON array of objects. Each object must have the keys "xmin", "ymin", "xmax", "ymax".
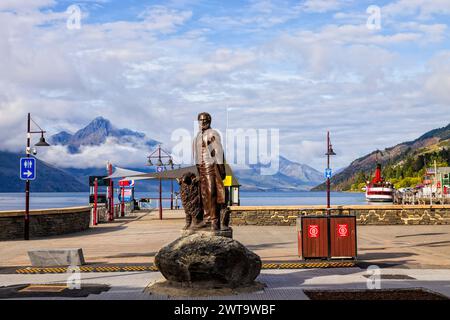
[{"xmin": 0, "ymin": 117, "xmax": 323, "ymax": 192}]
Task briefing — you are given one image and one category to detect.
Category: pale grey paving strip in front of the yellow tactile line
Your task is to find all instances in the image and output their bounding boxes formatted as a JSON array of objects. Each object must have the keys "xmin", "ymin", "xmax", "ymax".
[{"xmin": 0, "ymin": 268, "xmax": 450, "ymax": 300}]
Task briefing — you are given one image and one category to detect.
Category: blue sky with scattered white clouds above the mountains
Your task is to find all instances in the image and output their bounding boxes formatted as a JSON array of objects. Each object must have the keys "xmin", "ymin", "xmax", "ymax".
[{"xmin": 0, "ymin": 0, "xmax": 450, "ymax": 170}]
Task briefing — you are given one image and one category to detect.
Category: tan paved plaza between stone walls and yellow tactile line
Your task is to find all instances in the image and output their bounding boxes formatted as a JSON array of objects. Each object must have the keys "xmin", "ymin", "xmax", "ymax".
[{"xmin": 0, "ymin": 210, "xmax": 450, "ymax": 271}]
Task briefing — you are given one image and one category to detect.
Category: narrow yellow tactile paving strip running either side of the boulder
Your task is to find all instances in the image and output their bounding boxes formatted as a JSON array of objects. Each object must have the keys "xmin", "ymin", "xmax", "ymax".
[{"xmin": 16, "ymin": 261, "xmax": 355, "ymax": 274}]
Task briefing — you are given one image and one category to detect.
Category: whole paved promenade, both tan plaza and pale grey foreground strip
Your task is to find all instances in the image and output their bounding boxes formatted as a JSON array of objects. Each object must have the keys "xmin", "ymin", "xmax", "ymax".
[{"xmin": 0, "ymin": 211, "xmax": 450, "ymax": 300}]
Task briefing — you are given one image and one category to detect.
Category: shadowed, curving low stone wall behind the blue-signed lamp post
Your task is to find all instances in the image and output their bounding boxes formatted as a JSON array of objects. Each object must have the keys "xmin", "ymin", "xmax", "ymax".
[{"xmin": 0, "ymin": 207, "xmax": 91, "ymax": 240}]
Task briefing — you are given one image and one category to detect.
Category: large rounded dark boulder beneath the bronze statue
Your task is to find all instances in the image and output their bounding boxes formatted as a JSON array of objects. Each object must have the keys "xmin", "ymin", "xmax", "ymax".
[{"xmin": 155, "ymin": 232, "xmax": 262, "ymax": 288}]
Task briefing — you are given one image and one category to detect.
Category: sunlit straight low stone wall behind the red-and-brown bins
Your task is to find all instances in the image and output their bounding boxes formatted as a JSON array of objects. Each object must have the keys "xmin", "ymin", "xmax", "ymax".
[{"xmin": 230, "ymin": 205, "xmax": 450, "ymax": 226}]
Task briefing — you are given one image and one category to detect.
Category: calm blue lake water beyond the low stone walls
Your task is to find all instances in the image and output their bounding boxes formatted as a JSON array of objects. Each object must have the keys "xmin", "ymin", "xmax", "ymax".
[{"xmin": 0, "ymin": 191, "xmax": 366, "ymax": 211}]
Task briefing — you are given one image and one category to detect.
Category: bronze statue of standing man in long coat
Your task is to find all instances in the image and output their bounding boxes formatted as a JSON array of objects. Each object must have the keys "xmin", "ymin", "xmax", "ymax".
[{"xmin": 193, "ymin": 112, "xmax": 226, "ymax": 230}]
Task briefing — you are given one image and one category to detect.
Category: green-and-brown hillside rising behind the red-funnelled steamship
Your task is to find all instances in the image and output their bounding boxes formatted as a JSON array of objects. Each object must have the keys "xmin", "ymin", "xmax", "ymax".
[{"xmin": 312, "ymin": 124, "xmax": 450, "ymax": 191}]
